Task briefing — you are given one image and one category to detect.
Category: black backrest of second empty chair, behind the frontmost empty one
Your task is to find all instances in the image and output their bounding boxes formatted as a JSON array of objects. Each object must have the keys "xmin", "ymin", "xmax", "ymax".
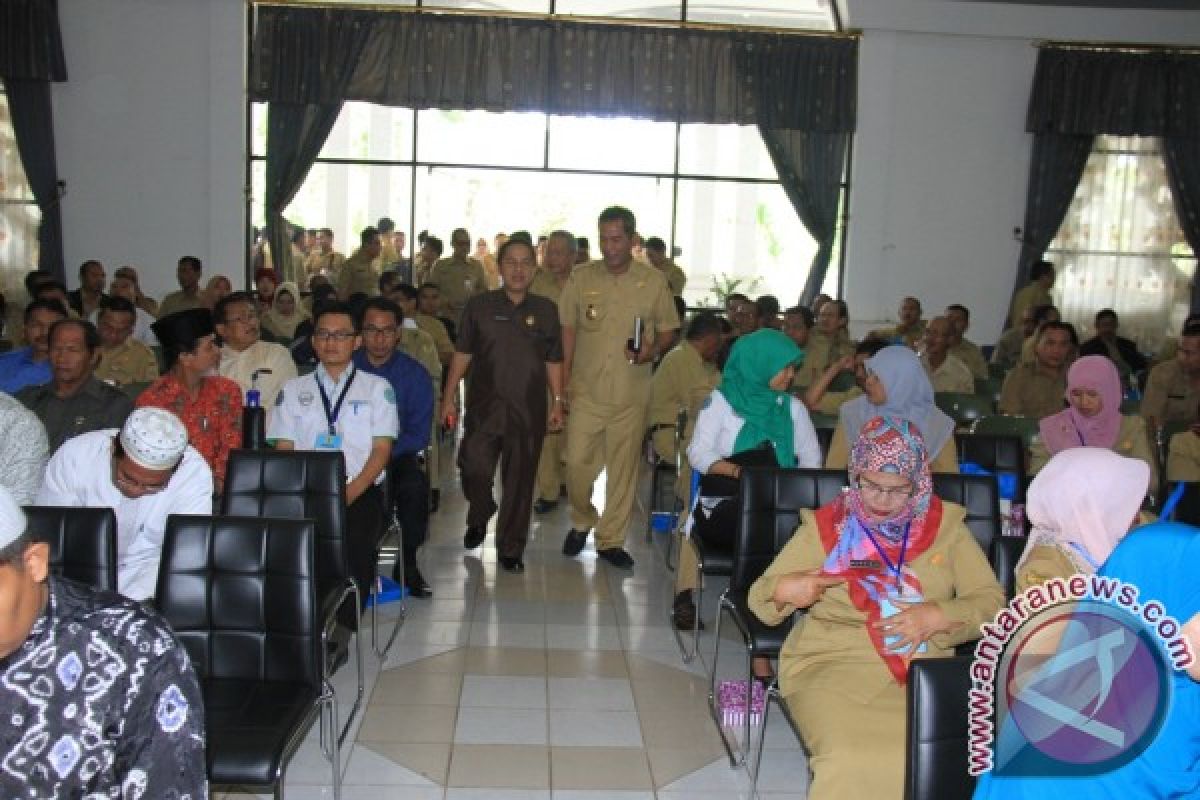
[{"xmin": 221, "ymin": 450, "xmax": 350, "ymax": 594}]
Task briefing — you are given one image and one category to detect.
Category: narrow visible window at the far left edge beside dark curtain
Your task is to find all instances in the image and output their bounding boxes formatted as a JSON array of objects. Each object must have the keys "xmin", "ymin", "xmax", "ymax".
[{"xmin": 0, "ymin": 90, "xmax": 42, "ymax": 338}]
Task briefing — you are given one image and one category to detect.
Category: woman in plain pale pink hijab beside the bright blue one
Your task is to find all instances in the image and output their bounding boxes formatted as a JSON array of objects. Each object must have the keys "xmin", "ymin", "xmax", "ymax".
[{"xmin": 1016, "ymin": 450, "xmax": 1151, "ymax": 593}]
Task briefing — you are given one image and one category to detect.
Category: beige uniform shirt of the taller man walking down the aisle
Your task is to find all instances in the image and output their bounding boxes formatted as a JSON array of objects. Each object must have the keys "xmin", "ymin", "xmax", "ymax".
[{"xmin": 558, "ymin": 260, "xmax": 679, "ymax": 405}]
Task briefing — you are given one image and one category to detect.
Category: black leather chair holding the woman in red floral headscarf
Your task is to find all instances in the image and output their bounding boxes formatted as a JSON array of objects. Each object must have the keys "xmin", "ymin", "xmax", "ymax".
[{"xmin": 708, "ymin": 467, "xmax": 846, "ymax": 766}]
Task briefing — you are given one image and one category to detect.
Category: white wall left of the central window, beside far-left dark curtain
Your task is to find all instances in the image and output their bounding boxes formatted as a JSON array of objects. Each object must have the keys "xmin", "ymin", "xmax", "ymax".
[{"xmin": 54, "ymin": 0, "xmax": 246, "ymax": 303}]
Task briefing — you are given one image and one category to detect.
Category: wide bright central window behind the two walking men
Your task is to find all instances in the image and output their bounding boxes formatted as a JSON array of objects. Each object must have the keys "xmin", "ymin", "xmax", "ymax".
[{"xmin": 252, "ymin": 103, "xmax": 839, "ymax": 306}]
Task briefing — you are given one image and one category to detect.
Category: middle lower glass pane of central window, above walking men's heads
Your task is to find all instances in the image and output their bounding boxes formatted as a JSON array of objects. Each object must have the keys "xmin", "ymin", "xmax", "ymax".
[{"xmin": 414, "ymin": 167, "xmax": 671, "ymax": 257}]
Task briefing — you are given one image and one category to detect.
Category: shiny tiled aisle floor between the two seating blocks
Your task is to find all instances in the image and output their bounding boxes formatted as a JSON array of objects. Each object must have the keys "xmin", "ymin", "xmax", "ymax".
[{"xmin": 224, "ymin": 459, "xmax": 808, "ymax": 800}]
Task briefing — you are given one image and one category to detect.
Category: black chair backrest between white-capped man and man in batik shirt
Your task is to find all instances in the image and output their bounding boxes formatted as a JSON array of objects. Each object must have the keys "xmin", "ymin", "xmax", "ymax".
[{"xmin": 25, "ymin": 506, "xmax": 116, "ymax": 591}]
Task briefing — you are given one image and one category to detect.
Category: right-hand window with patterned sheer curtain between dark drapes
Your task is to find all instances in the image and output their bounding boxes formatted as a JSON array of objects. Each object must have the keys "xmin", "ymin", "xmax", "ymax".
[{"xmin": 1046, "ymin": 136, "xmax": 1196, "ymax": 353}]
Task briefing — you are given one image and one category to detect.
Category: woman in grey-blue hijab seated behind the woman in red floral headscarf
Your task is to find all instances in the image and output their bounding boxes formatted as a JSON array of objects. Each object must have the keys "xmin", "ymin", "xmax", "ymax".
[{"xmin": 826, "ymin": 344, "xmax": 959, "ymax": 473}]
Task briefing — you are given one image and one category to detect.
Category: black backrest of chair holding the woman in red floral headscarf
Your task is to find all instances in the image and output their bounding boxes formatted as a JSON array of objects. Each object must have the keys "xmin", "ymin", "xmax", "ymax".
[{"xmin": 730, "ymin": 467, "xmax": 846, "ymax": 591}]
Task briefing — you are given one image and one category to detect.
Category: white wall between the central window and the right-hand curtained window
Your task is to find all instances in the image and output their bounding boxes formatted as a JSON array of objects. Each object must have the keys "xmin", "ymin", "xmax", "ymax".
[{"xmin": 845, "ymin": 0, "xmax": 1200, "ymax": 343}]
